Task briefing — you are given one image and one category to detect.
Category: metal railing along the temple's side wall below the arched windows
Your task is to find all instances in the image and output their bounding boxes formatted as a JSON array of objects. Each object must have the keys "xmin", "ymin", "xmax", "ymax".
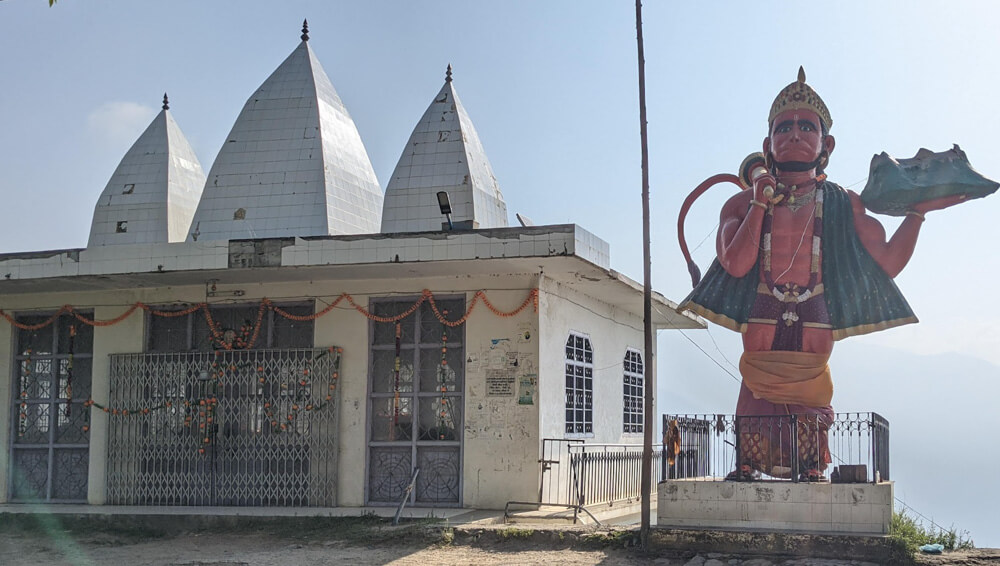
[{"xmin": 567, "ymin": 444, "xmax": 662, "ymax": 505}]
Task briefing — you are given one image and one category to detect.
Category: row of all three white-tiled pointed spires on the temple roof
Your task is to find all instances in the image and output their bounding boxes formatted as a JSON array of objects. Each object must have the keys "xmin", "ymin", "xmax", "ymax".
[{"xmin": 88, "ymin": 22, "xmax": 507, "ymax": 247}]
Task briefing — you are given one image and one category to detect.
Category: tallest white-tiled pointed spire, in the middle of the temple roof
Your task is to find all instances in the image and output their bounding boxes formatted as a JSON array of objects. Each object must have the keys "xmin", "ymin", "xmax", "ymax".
[{"xmin": 188, "ymin": 32, "xmax": 382, "ymax": 241}]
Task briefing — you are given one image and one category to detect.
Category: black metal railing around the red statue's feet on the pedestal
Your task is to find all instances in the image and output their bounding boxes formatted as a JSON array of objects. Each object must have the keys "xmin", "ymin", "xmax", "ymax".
[{"xmin": 660, "ymin": 413, "xmax": 890, "ymax": 483}]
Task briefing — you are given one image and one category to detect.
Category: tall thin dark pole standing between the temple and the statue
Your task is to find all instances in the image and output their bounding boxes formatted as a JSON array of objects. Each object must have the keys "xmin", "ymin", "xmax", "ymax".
[{"xmin": 635, "ymin": 0, "xmax": 656, "ymax": 548}]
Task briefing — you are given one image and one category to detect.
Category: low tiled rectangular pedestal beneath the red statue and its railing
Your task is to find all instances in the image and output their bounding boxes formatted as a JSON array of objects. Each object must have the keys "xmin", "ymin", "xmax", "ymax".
[{"xmin": 656, "ymin": 479, "xmax": 893, "ymax": 535}]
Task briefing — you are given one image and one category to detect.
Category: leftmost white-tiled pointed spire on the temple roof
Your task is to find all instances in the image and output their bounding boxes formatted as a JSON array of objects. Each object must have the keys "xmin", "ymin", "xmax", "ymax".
[{"xmin": 87, "ymin": 95, "xmax": 205, "ymax": 247}]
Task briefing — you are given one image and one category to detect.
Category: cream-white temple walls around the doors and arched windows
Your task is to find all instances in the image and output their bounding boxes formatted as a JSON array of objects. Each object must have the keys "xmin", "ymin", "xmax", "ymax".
[{"xmin": 0, "ymin": 274, "xmax": 632, "ymax": 509}]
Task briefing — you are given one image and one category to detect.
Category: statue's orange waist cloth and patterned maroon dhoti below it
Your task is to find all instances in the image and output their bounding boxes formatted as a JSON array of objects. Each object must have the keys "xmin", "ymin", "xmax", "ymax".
[{"xmin": 736, "ymin": 351, "xmax": 833, "ymax": 478}]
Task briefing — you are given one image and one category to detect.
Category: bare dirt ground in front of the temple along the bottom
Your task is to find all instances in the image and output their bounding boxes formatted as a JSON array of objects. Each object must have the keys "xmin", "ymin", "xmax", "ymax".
[{"xmin": 0, "ymin": 522, "xmax": 1000, "ymax": 566}]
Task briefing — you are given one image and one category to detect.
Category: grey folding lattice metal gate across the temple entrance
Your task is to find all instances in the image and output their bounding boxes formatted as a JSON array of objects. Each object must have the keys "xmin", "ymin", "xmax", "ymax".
[{"xmin": 108, "ymin": 348, "xmax": 340, "ymax": 506}]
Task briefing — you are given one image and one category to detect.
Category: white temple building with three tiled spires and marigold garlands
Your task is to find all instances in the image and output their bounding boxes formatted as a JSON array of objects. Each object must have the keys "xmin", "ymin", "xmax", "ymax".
[{"xmin": 0, "ymin": 22, "xmax": 704, "ymax": 509}]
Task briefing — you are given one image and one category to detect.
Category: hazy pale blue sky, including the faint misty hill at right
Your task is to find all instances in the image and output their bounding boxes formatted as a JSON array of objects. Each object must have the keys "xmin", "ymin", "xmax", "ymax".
[{"xmin": 0, "ymin": 0, "xmax": 1000, "ymax": 546}]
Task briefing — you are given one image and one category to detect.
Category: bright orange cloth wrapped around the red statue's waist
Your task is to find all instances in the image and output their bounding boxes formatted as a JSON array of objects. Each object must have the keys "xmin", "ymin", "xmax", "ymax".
[{"xmin": 740, "ymin": 351, "xmax": 833, "ymax": 407}]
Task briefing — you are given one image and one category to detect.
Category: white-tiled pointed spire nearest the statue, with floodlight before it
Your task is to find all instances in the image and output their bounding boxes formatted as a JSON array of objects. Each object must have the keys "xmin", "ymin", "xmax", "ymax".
[{"xmin": 382, "ymin": 65, "xmax": 507, "ymax": 233}]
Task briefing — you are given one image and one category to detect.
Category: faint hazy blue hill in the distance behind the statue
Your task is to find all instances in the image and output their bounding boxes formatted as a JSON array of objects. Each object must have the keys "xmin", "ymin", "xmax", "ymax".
[{"xmin": 831, "ymin": 340, "xmax": 1000, "ymax": 547}]
